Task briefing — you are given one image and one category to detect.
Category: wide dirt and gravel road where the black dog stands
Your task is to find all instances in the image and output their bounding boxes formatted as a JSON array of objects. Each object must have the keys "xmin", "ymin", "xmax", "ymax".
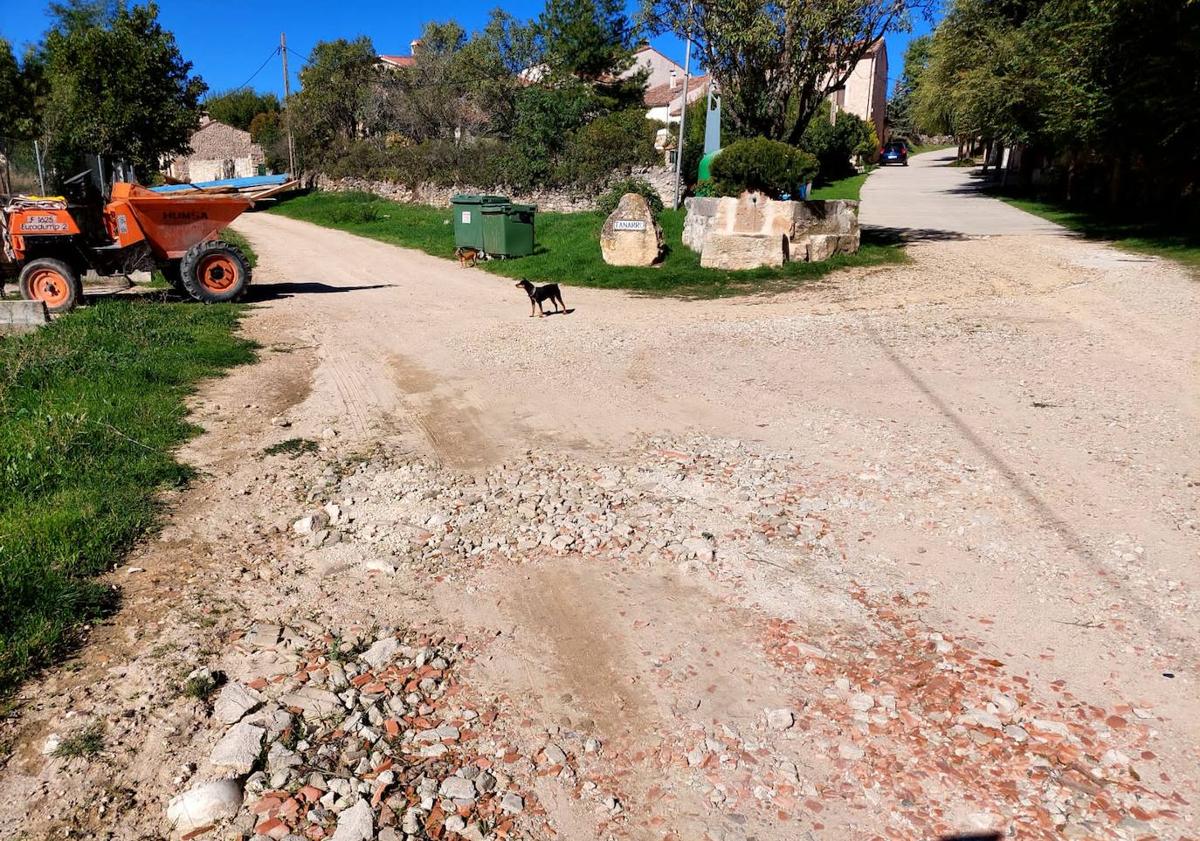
[{"xmin": 0, "ymin": 172, "xmax": 1200, "ymax": 841}]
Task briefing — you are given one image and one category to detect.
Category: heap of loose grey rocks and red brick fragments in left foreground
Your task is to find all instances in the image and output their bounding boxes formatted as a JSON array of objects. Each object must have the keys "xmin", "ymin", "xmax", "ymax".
[{"xmin": 167, "ymin": 623, "xmax": 529, "ymax": 841}]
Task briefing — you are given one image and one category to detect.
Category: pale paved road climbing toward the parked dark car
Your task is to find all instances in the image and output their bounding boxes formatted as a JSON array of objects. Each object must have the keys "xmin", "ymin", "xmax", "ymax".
[{"xmin": 862, "ymin": 150, "xmax": 1063, "ymax": 238}]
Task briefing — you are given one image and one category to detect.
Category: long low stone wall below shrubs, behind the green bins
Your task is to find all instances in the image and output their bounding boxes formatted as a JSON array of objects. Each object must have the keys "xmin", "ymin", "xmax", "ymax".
[{"xmin": 312, "ymin": 167, "xmax": 674, "ymax": 214}]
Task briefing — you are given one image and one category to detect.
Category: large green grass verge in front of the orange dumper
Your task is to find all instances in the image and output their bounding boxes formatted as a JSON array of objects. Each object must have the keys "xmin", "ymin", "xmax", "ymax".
[{"xmin": 0, "ymin": 299, "xmax": 253, "ymax": 695}]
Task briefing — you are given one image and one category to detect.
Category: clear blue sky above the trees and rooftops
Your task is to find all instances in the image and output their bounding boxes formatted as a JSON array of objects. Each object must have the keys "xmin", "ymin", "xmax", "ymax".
[{"xmin": 0, "ymin": 0, "xmax": 929, "ymax": 94}]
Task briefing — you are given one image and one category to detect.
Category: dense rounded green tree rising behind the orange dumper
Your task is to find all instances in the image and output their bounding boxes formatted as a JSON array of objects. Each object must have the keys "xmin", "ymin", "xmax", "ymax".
[{"xmin": 43, "ymin": 2, "xmax": 206, "ymax": 174}]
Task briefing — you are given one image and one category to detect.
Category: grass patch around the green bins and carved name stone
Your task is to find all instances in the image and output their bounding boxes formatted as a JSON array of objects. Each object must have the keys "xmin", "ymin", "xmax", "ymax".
[{"xmin": 270, "ymin": 192, "xmax": 905, "ymax": 298}]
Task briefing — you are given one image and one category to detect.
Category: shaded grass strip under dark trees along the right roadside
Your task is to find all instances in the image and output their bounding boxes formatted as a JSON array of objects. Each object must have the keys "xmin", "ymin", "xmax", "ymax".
[{"xmin": 992, "ymin": 192, "xmax": 1200, "ymax": 271}]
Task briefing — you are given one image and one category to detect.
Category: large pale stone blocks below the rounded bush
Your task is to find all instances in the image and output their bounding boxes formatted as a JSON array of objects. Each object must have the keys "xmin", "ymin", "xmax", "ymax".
[{"xmin": 683, "ymin": 193, "xmax": 860, "ymax": 270}]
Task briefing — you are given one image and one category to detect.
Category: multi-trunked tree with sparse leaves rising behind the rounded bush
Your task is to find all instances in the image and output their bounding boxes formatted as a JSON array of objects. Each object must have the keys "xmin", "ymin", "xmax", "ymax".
[{"xmin": 643, "ymin": 0, "xmax": 934, "ymax": 144}]
